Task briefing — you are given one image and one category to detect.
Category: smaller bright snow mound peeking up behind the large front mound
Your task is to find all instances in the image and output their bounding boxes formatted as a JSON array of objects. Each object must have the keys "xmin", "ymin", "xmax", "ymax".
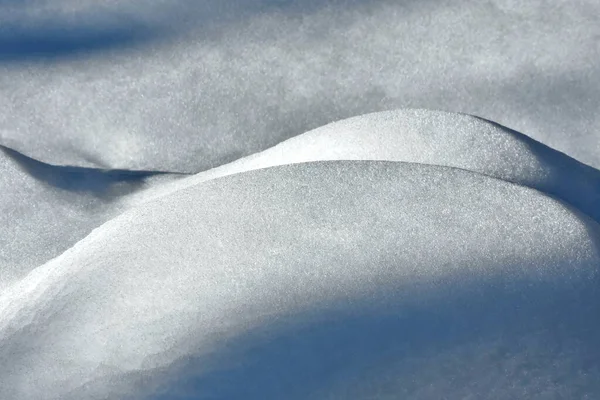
[{"xmin": 149, "ymin": 109, "xmax": 600, "ymax": 221}]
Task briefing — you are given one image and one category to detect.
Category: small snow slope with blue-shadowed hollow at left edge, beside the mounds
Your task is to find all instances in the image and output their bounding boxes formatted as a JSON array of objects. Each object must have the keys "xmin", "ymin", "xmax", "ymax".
[{"xmin": 0, "ymin": 148, "xmax": 183, "ymax": 291}]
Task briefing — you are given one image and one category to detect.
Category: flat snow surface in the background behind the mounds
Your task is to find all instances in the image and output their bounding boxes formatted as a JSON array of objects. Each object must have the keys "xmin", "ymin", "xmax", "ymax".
[{"xmin": 0, "ymin": 0, "xmax": 600, "ymax": 172}]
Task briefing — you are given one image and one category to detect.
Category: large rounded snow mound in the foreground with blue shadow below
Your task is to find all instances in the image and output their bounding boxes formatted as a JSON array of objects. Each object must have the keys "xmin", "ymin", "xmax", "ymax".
[{"xmin": 0, "ymin": 161, "xmax": 600, "ymax": 399}]
